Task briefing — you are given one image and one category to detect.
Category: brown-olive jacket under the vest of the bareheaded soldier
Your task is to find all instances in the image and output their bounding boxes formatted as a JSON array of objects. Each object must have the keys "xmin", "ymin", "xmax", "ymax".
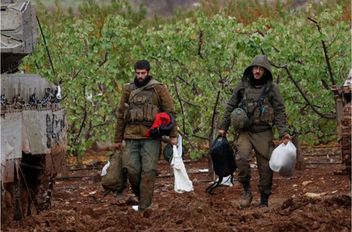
[{"xmin": 115, "ymin": 79, "xmax": 177, "ymax": 143}]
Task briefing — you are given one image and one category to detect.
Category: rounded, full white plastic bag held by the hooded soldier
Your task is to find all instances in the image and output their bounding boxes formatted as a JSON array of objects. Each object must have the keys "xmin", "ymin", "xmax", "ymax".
[{"xmin": 269, "ymin": 141, "xmax": 296, "ymax": 177}]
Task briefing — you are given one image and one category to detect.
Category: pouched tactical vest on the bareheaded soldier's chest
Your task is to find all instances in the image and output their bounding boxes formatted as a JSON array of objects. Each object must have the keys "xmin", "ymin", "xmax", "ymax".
[{"xmin": 125, "ymin": 80, "xmax": 160, "ymax": 127}]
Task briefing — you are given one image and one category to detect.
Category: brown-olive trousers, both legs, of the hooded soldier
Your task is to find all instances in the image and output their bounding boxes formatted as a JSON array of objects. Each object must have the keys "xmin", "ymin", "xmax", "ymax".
[{"xmin": 236, "ymin": 130, "xmax": 273, "ymax": 195}]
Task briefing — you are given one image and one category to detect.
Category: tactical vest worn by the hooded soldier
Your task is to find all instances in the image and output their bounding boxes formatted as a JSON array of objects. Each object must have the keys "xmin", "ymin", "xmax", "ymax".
[{"xmin": 239, "ymin": 85, "xmax": 274, "ymax": 126}]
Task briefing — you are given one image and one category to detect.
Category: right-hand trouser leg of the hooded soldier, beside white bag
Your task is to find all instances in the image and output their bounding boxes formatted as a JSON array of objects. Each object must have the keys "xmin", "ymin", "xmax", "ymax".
[{"xmin": 250, "ymin": 131, "xmax": 273, "ymax": 197}]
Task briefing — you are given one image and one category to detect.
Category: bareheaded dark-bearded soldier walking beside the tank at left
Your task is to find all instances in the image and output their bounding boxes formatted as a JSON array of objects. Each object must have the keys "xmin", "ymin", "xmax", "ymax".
[{"xmin": 114, "ymin": 60, "xmax": 177, "ymax": 212}]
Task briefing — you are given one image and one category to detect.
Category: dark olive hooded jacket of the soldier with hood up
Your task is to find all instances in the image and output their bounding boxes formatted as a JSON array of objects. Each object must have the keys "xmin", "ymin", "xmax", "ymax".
[{"xmin": 219, "ymin": 56, "xmax": 289, "ymax": 137}]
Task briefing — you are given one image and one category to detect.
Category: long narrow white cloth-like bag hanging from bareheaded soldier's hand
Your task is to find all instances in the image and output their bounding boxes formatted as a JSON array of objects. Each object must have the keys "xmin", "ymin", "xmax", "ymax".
[{"xmin": 171, "ymin": 135, "xmax": 193, "ymax": 193}]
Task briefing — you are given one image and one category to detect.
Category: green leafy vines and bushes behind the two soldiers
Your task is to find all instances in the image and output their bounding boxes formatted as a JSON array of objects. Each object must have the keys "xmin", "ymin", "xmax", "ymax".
[{"xmin": 22, "ymin": 1, "xmax": 351, "ymax": 156}]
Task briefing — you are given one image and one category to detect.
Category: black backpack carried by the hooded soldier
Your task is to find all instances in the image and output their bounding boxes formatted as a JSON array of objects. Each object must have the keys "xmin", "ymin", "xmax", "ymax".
[{"xmin": 206, "ymin": 136, "xmax": 236, "ymax": 194}]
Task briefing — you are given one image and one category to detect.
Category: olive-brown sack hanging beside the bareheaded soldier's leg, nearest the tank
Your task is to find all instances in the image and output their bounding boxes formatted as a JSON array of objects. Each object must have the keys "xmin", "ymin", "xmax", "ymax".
[{"xmin": 101, "ymin": 151, "xmax": 127, "ymax": 193}]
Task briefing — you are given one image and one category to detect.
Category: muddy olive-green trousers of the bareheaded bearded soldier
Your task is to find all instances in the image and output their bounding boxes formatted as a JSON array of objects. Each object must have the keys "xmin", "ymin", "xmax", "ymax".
[{"xmin": 122, "ymin": 139, "xmax": 160, "ymax": 210}]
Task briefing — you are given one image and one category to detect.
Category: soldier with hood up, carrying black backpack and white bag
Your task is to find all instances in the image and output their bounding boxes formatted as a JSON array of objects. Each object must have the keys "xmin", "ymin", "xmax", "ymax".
[{"xmin": 219, "ymin": 55, "xmax": 291, "ymax": 208}]
